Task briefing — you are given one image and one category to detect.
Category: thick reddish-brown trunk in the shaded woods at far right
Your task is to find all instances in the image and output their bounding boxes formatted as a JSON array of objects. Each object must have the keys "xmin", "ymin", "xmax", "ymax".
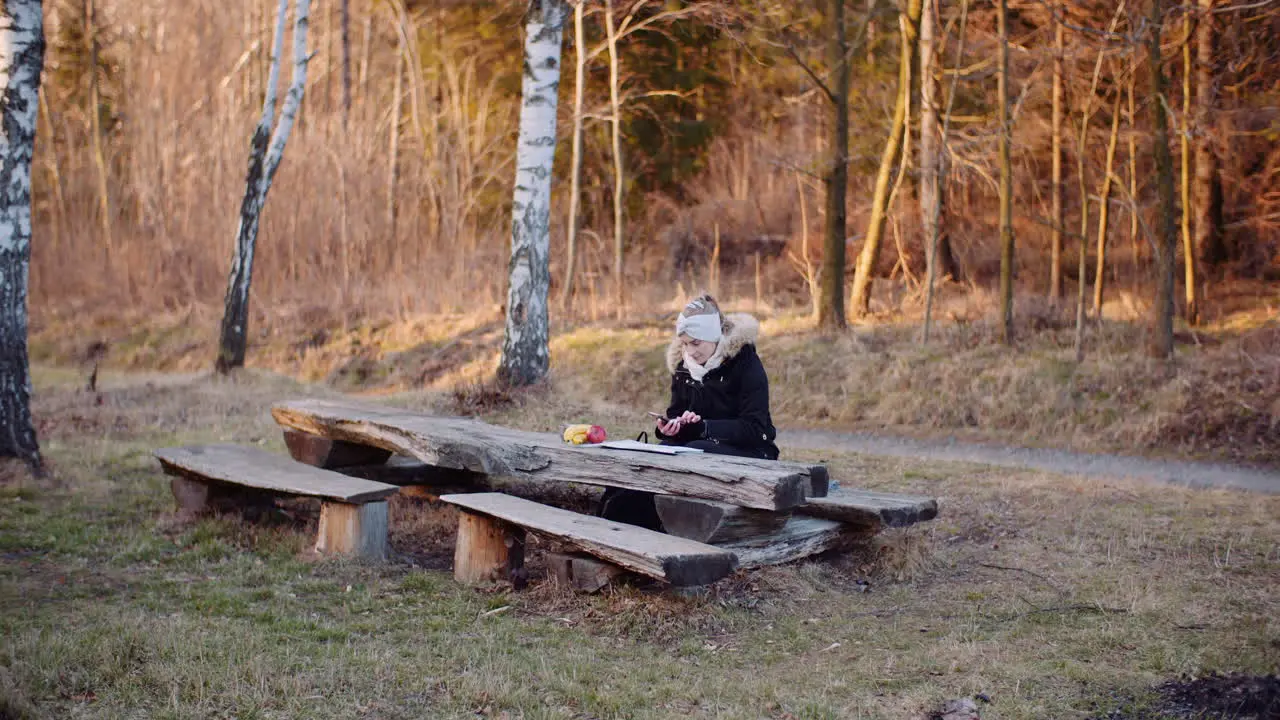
[{"xmin": 1193, "ymin": 0, "xmax": 1228, "ymax": 268}]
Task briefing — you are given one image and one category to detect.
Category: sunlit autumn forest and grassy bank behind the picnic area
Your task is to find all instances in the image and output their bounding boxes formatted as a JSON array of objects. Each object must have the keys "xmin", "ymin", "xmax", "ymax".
[{"xmin": 22, "ymin": 0, "xmax": 1280, "ymax": 461}]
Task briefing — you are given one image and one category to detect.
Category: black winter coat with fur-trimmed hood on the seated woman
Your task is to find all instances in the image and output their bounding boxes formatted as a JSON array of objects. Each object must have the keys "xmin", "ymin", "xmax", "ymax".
[{"xmin": 658, "ymin": 315, "xmax": 778, "ymax": 460}]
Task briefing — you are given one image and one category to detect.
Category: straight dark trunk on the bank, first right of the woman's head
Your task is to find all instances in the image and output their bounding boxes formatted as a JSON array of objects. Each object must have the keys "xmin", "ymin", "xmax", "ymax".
[{"xmin": 818, "ymin": 0, "xmax": 849, "ymax": 331}]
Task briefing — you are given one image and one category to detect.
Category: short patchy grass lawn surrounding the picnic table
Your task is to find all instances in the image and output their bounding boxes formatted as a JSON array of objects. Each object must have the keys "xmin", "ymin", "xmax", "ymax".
[{"xmin": 0, "ymin": 372, "xmax": 1280, "ymax": 719}]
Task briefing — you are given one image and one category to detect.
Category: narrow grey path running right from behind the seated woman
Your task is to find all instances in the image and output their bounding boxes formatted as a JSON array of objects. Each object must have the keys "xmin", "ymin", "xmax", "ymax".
[{"xmin": 778, "ymin": 429, "xmax": 1280, "ymax": 493}]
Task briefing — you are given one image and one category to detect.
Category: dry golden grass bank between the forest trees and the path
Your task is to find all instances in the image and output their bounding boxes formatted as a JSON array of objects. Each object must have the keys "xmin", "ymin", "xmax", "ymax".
[{"xmin": 32, "ymin": 274, "xmax": 1280, "ymax": 464}]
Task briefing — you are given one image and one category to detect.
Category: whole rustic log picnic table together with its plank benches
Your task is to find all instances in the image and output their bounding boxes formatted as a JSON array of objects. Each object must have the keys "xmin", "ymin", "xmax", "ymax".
[{"xmin": 155, "ymin": 400, "xmax": 937, "ymax": 588}]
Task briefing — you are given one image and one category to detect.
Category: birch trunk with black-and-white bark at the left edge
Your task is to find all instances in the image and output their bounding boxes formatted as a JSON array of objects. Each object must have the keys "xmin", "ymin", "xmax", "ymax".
[{"xmin": 0, "ymin": 0, "xmax": 45, "ymax": 471}]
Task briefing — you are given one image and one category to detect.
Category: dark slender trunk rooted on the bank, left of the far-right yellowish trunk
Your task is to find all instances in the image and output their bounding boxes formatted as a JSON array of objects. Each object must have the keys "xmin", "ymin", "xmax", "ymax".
[{"xmin": 1147, "ymin": 0, "xmax": 1178, "ymax": 357}]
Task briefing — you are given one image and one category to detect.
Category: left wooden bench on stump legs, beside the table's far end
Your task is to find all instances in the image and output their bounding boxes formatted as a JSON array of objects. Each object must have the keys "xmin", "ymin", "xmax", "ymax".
[{"xmin": 155, "ymin": 445, "xmax": 399, "ymax": 560}]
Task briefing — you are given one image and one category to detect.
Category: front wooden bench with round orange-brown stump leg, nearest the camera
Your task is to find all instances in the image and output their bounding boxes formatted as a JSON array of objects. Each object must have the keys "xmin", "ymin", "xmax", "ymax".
[{"xmin": 440, "ymin": 492, "xmax": 737, "ymax": 585}]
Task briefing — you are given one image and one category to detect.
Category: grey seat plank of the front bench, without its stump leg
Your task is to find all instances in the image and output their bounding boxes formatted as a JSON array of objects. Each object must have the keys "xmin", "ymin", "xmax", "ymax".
[{"xmin": 440, "ymin": 492, "xmax": 736, "ymax": 585}]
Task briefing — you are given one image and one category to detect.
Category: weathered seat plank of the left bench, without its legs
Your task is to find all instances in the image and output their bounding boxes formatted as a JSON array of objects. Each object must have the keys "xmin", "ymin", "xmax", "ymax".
[{"xmin": 155, "ymin": 445, "xmax": 399, "ymax": 503}]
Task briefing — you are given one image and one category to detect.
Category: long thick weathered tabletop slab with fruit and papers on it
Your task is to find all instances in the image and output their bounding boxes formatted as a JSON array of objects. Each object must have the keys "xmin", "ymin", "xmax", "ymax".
[{"xmin": 271, "ymin": 400, "xmax": 822, "ymax": 510}]
